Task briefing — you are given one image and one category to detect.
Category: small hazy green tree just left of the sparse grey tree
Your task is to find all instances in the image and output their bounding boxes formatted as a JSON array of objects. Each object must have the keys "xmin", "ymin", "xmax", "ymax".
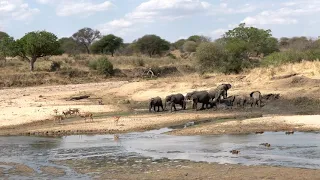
[{"xmin": 59, "ymin": 37, "xmax": 87, "ymax": 55}]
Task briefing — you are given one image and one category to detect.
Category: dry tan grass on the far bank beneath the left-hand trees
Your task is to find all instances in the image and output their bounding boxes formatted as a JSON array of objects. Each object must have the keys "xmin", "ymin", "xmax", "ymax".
[{"xmin": 0, "ymin": 54, "xmax": 192, "ymax": 87}]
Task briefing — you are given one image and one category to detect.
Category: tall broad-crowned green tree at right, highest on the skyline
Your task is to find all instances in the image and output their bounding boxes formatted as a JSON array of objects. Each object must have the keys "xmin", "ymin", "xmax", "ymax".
[{"xmin": 223, "ymin": 23, "xmax": 278, "ymax": 56}]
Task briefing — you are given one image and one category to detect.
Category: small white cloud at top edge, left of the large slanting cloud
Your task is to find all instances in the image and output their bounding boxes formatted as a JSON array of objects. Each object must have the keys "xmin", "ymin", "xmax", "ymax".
[{"xmin": 57, "ymin": 0, "xmax": 113, "ymax": 16}]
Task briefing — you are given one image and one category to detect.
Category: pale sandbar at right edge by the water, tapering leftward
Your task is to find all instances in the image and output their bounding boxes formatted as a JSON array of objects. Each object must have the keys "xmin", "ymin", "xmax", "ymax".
[{"xmin": 168, "ymin": 115, "xmax": 320, "ymax": 135}]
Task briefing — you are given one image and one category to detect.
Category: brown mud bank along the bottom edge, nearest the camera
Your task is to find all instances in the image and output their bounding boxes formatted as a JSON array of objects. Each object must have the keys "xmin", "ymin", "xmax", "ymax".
[{"xmin": 55, "ymin": 157, "xmax": 320, "ymax": 180}]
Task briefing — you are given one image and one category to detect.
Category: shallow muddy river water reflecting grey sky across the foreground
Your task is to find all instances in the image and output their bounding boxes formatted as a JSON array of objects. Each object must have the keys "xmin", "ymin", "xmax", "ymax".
[{"xmin": 0, "ymin": 128, "xmax": 320, "ymax": 179}]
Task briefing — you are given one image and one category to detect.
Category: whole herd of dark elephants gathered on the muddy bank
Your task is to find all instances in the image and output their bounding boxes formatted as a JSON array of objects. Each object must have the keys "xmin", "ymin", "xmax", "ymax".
[{"xmin": 149, "ymin": 84, "xmax": 262, "ymax": 112}]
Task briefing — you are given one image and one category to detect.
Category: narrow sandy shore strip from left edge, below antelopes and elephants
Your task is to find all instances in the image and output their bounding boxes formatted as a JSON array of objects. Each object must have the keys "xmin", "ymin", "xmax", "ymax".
[{"xmin": 0, "ymin": 111, "xmax": 261, "ymax": 136}]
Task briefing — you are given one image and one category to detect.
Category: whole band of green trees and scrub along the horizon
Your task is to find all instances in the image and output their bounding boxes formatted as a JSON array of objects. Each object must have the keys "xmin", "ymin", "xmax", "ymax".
[{"xmin": 0, "ymin": 24, "xmax": 320, "ymax": 82}]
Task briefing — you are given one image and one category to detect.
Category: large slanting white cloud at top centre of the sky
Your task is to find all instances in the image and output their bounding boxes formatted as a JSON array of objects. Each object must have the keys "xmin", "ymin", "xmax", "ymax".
[{"xmin": 97, "ymin": 0, "xmax": 211, "ymax": 34}]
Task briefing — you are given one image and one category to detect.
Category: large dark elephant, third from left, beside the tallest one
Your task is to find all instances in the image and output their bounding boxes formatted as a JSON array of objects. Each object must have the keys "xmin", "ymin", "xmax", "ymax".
[{"xmin": 186, "ymin": 91, "xmax": 213, "ymax": 110}]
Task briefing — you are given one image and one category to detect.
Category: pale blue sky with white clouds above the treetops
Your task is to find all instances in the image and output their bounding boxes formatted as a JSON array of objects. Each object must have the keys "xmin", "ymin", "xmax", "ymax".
[{"xmin": 0, "ymin": 0, "xmax": 320, "ymax": 42}]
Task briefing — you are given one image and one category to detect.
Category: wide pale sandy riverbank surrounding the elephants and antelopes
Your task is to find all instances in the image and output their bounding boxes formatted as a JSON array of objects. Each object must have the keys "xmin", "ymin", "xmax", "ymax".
[{"xmin": 0, "ymin": 71, "xmax": 320, "ymax": 135}]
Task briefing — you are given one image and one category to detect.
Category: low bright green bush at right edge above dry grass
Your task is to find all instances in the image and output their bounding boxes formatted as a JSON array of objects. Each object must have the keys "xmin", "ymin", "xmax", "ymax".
[{"xmin": 261, "ymin": 50, "xmax": 320, "ymax": 66}]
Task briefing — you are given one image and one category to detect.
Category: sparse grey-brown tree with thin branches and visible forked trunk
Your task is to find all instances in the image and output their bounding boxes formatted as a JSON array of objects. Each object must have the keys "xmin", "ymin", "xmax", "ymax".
[{"xmin": 72, "ymin": 27, "xmax": 101, "ymax": 54}]
